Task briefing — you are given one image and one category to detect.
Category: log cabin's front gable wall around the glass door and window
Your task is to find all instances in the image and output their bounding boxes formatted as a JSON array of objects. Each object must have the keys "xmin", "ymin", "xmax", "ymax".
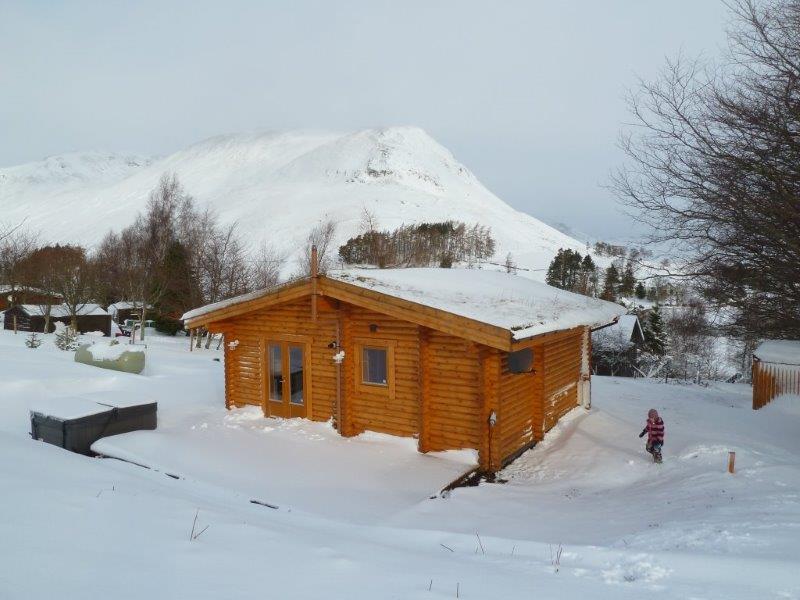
[{"xmin": 222, "ymin": 298, "xmax": 494, "ymax": 451}]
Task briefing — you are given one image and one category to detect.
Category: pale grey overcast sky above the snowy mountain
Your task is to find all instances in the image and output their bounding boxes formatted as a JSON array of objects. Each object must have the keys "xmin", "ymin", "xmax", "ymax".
[{"xmin": 0, "ymin": 0, "xmax": 727, "ymax": 239}]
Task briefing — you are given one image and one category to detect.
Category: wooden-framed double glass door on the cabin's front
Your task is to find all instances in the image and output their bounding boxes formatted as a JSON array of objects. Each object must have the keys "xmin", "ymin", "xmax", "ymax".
[{"xmin": 266, "ymin": 341, "xmax": 306, "ymax": 417}]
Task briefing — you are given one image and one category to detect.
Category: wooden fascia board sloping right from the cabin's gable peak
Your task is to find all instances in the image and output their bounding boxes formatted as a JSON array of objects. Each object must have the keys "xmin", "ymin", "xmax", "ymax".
[{"xmin": 318, "ymin": 277, "xmax": 511, "ymax": 350}]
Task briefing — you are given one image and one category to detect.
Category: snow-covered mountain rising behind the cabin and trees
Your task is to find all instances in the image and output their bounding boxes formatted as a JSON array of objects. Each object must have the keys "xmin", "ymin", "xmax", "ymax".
[{"xmin": 0, "ymin": 127, "xmax": 585, "ymax": 279}]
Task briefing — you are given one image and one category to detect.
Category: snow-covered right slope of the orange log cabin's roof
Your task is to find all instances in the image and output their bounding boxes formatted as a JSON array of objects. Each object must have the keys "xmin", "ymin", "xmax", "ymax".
[{"xmin": 328, "ymin": 268, "xmax": 625, "ymax": 339}]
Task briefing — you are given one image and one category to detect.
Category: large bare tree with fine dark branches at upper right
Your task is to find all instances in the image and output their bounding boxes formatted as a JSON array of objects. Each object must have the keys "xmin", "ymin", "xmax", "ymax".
[{"xmin": 613, "ymin": 0, "xmax": 800, "ymax": 337}]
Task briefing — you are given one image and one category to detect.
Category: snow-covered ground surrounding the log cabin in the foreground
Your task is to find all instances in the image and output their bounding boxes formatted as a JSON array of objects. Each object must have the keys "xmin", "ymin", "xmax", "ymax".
[{"xmin": 0, "ymin": 331, "xmax": 800, "ymax": 600}]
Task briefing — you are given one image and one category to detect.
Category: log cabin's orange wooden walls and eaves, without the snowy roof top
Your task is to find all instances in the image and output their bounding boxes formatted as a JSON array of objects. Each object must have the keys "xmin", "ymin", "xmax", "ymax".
[{"xmin": 188, "ymin": 277, "xmax": 600, "ymax": 472}]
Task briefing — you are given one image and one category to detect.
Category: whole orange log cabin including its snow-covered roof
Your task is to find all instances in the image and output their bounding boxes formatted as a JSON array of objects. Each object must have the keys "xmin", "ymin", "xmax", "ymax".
[{"xmin": 183, "ymin": 258, "xmax": 625, "ymax": 472}]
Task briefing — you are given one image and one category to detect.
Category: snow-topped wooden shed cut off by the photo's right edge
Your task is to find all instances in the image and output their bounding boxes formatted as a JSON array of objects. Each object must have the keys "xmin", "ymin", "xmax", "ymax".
[{"xmin": 753, "ymin": 340, "xmax": 800, "ymax": 410}]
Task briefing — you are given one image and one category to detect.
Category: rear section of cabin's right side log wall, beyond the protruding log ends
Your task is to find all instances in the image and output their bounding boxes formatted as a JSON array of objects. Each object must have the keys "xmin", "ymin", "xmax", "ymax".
[{"xmin": 543, "ymin": 331, "xmax": 583, "ymax": 432}]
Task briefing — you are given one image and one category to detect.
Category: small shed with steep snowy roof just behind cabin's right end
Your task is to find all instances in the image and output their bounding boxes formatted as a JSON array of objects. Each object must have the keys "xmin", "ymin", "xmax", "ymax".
[{"xmin": 592, "ymin": 315, "xmax": 644, "ymax": 377}]
